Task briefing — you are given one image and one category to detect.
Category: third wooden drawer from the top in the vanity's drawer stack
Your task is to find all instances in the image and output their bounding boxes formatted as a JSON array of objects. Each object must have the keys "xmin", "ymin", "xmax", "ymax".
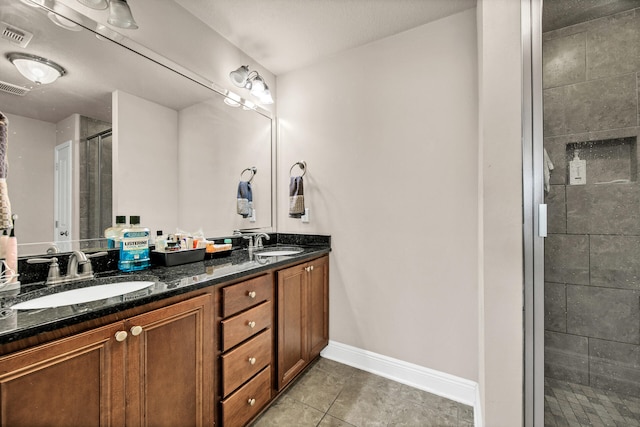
[{"xmin": 222, "ymin": 329, "xmax": 272, "ymax": 396}]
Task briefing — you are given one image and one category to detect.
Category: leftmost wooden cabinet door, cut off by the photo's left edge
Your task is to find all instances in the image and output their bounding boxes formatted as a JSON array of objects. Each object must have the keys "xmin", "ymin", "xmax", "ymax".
[{"xmin": 0, "ymin": 322, "xmax": 126, "ymax": 427}]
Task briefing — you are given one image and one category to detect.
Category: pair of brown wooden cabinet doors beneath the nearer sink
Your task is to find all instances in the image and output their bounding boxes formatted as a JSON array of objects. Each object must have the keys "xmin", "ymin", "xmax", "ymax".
[{"xmin": 0, "ymin": 294, "xmax": 213, "ymax": 427}]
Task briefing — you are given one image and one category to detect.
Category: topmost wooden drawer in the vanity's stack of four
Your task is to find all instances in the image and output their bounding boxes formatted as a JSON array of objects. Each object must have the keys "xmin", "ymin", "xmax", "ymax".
[{"xmin": 222, "ymin": 274, "xmax": 273, "ymax": 317}]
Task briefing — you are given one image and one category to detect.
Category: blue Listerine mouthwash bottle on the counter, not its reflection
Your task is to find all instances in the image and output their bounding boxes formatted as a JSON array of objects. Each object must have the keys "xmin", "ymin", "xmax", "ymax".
[{"xmin": 118, "ymin": 216, "xmax": 149, "ymax": 271}]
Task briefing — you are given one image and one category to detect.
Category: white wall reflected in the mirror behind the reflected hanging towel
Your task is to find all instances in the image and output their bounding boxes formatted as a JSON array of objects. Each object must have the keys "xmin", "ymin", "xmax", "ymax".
[{"xmin": 176, "ymin": 97, "xmax": 272, "ymax": 237}]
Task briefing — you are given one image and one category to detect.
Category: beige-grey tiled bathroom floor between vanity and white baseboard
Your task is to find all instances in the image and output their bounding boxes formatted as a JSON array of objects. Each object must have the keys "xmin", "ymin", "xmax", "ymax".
[{"xmin": 252, "ymin": 358, "xmax": 473, "ymax": 427}]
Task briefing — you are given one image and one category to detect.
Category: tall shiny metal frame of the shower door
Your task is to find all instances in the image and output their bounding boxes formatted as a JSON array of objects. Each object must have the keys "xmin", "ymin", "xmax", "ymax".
[{"xmin": 521, "ymin": 0, "xmax": 546, "ymax": 427}]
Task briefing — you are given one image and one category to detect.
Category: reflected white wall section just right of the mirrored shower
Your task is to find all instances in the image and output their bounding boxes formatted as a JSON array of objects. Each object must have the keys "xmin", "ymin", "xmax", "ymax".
[{"xmin": 112, "ymin": 91, "xmax": 178, "ymax": 236}]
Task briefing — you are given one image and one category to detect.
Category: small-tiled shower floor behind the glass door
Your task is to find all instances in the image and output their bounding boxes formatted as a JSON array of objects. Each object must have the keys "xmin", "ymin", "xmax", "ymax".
[{"xmin": 544, "ymin": 378, "xmax": 640, "ymax": 427}]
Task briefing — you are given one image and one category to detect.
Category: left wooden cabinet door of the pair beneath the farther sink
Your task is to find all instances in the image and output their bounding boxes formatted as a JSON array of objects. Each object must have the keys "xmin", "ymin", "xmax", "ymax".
[{"xmin": 278, "ymin": 264, "xmax": 309, "ymax": 390}]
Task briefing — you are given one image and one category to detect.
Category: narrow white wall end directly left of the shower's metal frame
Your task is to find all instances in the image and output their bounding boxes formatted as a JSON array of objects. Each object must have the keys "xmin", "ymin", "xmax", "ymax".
[{"xmin": 478, "ymin": 0, "xmax": 524, "ymax": 427}]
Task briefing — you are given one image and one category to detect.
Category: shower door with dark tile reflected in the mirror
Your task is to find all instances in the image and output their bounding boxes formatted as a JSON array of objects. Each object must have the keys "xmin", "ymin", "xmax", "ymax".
[{"xmin": 80, "ymin": 129, "xmax": 112, "ymax": 240}]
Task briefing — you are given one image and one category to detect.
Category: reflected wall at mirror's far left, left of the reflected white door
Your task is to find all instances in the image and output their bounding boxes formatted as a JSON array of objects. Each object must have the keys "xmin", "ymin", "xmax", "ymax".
[{"xmin": 7, "ymin": 114, "xmax": 56, "ymax": 243}]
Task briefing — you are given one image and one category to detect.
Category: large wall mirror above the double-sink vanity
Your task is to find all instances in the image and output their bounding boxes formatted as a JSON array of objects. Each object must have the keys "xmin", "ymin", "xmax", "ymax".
[{"xmin": 0, "ymin": 0, "xmax": 274, "ymax": 255}]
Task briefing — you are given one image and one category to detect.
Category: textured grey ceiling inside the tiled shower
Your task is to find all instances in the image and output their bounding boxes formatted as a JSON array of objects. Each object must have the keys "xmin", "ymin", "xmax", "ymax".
[{"xmin": 542, "ymin": 0, "xmax": 640, "ymax": 32}]
